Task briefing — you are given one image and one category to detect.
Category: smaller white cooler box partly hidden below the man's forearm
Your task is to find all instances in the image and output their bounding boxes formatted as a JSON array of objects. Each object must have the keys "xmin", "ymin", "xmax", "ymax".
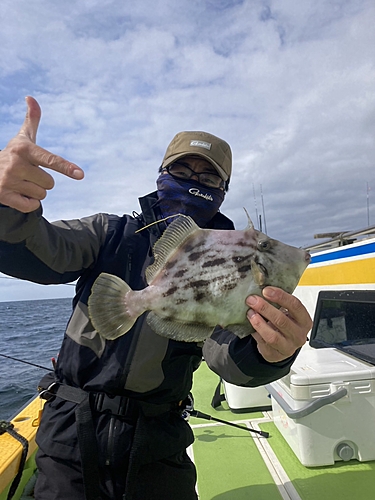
[{"xmin": 223, "ymin": 380, "xmax": 271, "ymax": 413}]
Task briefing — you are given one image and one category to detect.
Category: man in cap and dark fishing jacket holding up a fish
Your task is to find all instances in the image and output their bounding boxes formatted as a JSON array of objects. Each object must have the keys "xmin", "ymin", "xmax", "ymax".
[{"xmin": 0, "ymin": 97, "xmax": 311, "ymax": 500}]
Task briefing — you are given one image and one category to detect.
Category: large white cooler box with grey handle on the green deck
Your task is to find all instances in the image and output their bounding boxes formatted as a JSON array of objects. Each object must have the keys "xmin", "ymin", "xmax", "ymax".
[{"xmin": 266, "ymin": 348, "xmax": 375, "ymax": 466}]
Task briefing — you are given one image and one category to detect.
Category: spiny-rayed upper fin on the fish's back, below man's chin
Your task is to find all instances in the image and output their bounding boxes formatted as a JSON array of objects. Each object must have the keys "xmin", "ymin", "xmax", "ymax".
[{"xmin": 146, "ymin": 215, "xmax": 202, "ymax": 284}]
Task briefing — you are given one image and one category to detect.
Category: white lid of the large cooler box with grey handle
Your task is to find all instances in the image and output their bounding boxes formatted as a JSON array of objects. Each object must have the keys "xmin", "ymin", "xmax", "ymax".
[{"xmin": 289, "ymin": 348, "xmax": 375, "ymax": 386}]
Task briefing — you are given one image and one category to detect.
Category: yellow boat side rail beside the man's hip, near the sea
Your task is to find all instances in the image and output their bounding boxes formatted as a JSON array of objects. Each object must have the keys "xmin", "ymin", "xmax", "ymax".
[{"xmin": 0, "ymin": 397, "xmax": 43, "ymax": 497}]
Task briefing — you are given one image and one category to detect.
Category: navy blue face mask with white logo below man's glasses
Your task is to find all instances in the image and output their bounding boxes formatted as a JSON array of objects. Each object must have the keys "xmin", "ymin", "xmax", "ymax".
[{"xmin": 156, "ymin": 174, "xmax": 225, "ymax": 227}]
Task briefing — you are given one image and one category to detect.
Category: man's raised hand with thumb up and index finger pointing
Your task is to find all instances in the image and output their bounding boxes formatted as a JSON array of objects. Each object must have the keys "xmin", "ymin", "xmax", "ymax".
[{"xmin": 0, "ymin": 97, "xmax": 84, "ymax": 213}]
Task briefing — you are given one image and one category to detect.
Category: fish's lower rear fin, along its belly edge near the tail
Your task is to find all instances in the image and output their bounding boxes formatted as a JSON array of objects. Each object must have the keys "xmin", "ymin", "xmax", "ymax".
[{"xmin": 147, "ymin": 311, "xmax": 214, "ymax": 342}]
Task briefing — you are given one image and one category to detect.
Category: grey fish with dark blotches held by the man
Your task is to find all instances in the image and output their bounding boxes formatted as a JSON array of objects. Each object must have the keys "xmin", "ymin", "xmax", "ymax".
[{"xmin": 88, "ymin": 210, "xmax": 310, "ymax": 342}]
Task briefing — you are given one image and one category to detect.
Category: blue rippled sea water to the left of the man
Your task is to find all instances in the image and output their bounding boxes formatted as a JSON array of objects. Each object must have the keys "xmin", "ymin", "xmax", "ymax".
[{"xmin": 0, "ymin": 298, "xmax": 72, "ymax": 420}]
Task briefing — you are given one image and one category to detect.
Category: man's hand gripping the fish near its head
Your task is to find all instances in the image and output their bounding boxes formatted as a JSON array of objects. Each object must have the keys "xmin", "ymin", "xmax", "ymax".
[{"xmin": 246, "ymin": 286, "xmax": 312, "ymax": 363}]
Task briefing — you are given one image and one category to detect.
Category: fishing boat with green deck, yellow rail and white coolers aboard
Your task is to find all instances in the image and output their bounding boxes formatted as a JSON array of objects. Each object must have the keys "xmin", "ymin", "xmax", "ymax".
[{"xmin": 0, "ymin": 226, "xmax": 375, "ymax": 500}]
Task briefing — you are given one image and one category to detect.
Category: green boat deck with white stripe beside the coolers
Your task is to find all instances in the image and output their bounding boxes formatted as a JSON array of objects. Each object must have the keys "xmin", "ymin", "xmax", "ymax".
[{"xmin": 189, "ymin": 363, "xmax": 375, "ymax": 500}]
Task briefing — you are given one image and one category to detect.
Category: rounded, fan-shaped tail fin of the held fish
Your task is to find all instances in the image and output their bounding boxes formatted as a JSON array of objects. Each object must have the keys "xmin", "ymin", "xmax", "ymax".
[{"xmin": 88, "ymin": 273, "xmax": 138, "ymax": 340}]
